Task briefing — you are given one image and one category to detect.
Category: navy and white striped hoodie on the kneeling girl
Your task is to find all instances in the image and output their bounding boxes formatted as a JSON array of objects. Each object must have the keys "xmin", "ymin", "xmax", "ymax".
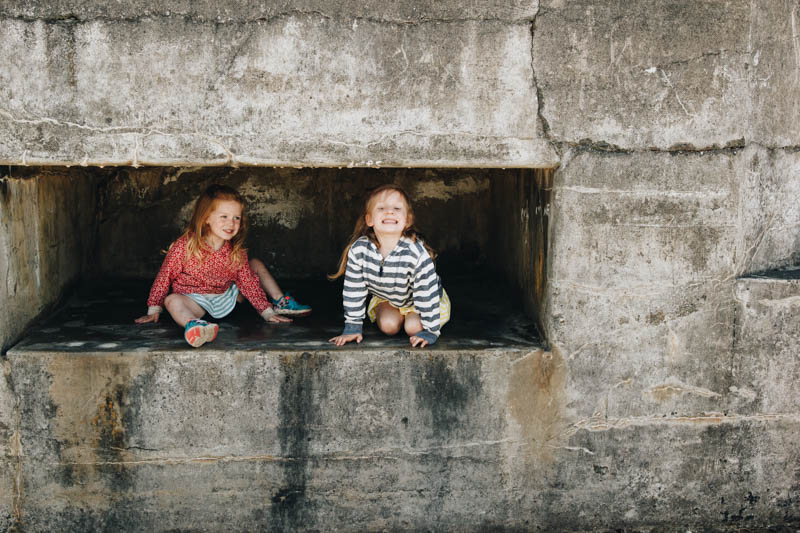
[{"xmin": 342, "ymin": 237, "xmax": 442, "ymax": 344}]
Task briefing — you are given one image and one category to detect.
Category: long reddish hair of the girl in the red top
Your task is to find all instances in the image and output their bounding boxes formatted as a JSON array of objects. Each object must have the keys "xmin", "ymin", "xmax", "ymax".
[{"xmin": 181, "ymin": 184, "xmax": 247, "ymax": 267}]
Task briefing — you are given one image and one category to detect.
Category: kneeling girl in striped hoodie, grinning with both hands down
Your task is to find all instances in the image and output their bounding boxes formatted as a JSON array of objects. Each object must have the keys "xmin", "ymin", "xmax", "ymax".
[{"xmin": 328, "ymin": 185, "xmax": 450, "ymax": 348}]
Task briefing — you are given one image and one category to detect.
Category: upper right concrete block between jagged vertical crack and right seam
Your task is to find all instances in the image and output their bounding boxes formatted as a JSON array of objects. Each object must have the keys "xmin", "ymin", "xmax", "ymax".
[{"xmin": 533, "ymin": 0, "xmax": 753, "ymax": 150}]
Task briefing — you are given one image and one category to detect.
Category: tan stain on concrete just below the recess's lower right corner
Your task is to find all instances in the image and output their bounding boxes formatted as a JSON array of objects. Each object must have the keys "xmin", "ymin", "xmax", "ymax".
[{"xmin": 507, "ymin": 350, "xmax": 567, "ymax": 467}]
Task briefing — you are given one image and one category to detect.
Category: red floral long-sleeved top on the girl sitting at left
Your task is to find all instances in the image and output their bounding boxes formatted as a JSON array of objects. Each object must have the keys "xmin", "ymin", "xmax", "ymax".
[{"xmin": 147, "ymin": 236, "xmax": 272, "ymax": 314}]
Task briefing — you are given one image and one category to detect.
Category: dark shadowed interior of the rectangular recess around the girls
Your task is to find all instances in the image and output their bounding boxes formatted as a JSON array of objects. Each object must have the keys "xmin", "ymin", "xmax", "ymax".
[{"xmin": 9, "ymin": 167, "xmax": 553, "ymax": 351}]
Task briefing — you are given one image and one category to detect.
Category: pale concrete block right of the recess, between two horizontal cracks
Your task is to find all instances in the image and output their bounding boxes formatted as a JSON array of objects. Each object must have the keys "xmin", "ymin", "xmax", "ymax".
[{"xmin": 546, "ymin": 150, "xmax": 741, "ymax": 417}]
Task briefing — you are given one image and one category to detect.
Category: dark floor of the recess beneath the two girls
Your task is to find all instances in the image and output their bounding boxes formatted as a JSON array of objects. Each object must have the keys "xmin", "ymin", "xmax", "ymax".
[{"xmin": 10, "ymin": 276, "xmax": 543, "ymax": 356}]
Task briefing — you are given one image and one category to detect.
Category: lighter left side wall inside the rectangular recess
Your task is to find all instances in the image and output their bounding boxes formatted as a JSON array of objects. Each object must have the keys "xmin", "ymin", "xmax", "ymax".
[{"xmin": 0, "ymin": 167, "xmax": 95, "ymax": 350}]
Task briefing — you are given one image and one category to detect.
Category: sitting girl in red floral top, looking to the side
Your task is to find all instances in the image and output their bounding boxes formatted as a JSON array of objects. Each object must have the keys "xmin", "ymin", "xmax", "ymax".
[{"xmin": 136, "ymin": 185, "xmax": 311, "ymax": 347}]
